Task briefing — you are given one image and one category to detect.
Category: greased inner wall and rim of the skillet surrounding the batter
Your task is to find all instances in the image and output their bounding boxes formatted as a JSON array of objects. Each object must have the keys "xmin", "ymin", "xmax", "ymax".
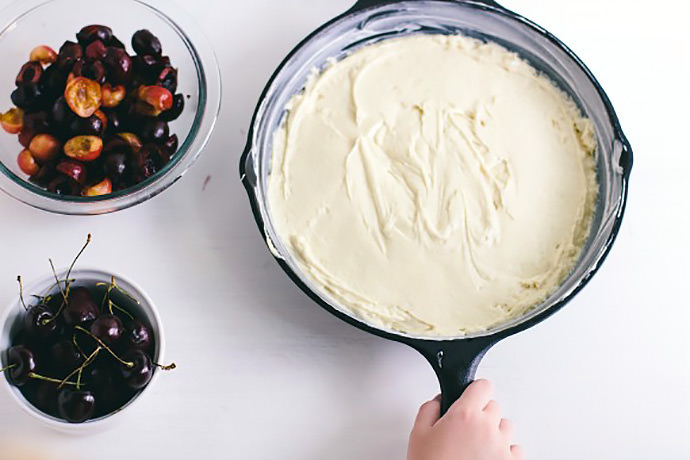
[{"xmin": 240, "ymin": 0, "xmax": 632, "ymax": 343}]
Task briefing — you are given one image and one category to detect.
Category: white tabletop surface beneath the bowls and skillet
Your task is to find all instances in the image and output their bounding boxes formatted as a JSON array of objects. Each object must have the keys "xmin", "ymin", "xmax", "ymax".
[{"xmin": 0, "ymin": 0, "xmax": 690, "ymax": 460}]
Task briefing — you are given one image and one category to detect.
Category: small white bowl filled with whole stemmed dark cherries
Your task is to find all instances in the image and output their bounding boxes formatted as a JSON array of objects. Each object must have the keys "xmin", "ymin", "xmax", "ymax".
[{"xmin": 0, "ymin": 236, "xmax": 175, "ymax": 431}]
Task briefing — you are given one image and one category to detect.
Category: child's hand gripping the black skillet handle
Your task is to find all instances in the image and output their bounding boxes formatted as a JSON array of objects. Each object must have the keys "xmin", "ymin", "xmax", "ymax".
[{"xmin": 407, "ymin": 380, "xmax": 523, "ymax": 460}]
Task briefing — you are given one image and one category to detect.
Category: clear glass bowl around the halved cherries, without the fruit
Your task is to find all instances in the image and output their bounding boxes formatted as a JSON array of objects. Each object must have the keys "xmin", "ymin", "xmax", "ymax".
[{"xmin": 0, "ymin": 0, "xmax": 221, "ymax": 215}]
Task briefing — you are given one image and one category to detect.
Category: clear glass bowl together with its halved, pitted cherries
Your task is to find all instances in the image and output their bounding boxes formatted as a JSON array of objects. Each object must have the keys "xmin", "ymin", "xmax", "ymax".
[{"xmin": 0, "ymin": 0, "xmax": 220, "ymax": 215}]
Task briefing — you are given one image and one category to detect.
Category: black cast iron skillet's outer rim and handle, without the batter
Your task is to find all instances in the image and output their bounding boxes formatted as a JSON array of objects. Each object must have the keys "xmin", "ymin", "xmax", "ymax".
[{"xmin": 240, "ymin": 0, "xmax": 633, "ymax": 412}]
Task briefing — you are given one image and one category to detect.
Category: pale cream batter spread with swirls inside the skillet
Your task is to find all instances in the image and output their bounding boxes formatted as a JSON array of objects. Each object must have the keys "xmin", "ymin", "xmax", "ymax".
[{"xmin": 269, "ymin": 35, "xmax": 598, "ymax": 336}]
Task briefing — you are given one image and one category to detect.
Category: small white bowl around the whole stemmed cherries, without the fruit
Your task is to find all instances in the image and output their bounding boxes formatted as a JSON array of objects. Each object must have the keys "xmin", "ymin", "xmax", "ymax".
[{"xmin": 0, "ymin": 268, "xmax": 165, "ymax": 434}]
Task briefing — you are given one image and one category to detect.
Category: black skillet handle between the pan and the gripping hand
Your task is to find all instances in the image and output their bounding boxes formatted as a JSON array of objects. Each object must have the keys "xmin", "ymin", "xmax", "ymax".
[{"xmin": 412, "ymin": 338, "xmax": 496, "ymax": 415}]
